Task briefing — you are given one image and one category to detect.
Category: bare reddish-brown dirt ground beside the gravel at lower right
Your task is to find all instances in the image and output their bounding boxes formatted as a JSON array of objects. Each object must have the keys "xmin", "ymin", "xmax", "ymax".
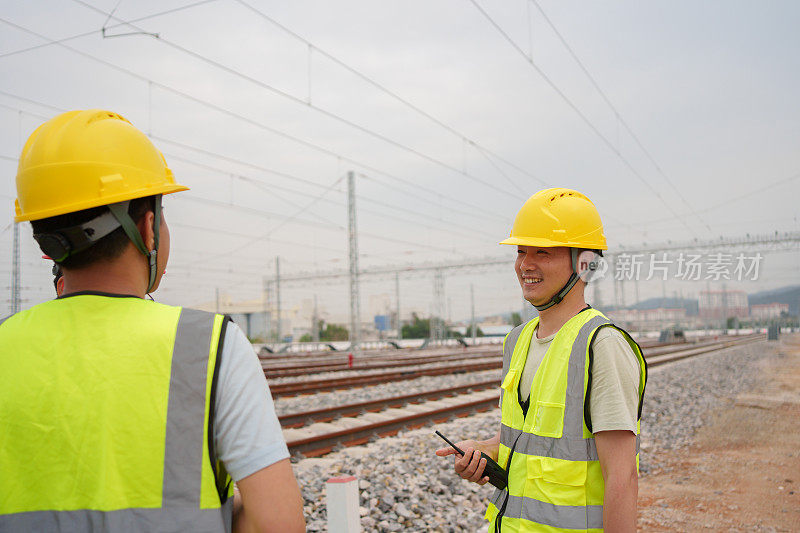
[{"xmin": 638, "ymin": 334, "xmax": 800, "ymax": 532}]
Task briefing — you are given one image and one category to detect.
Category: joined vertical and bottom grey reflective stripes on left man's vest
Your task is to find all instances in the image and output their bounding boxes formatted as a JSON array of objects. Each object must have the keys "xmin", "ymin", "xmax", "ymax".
[{"xmin": 0, "ymin": 309, "xmax": 233, "ymax": 533}]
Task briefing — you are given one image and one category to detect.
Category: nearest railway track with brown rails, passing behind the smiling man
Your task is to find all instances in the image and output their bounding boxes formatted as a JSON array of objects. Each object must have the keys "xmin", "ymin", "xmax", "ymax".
[{"xmin": 279, "ymin": 334, "xmax": 765, "ymax": 457}]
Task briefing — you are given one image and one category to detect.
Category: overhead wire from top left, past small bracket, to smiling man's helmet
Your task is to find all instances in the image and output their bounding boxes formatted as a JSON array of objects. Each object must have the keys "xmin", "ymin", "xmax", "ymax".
[{"xmin": 67, "ymin": 0, "xmax": 517, "ymax": 202}]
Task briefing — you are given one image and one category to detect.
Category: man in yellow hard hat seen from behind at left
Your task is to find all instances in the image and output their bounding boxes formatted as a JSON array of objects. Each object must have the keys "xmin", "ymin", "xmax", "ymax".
[{"xmin": 0, "ymin": 110, "xmax": 304, "ymax": 532}]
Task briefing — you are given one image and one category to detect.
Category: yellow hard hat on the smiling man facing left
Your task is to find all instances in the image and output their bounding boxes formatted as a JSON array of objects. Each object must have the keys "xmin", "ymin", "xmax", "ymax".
[{"xmin": 500, "ymin": 188, "xmax": 608, "ymax": 250}]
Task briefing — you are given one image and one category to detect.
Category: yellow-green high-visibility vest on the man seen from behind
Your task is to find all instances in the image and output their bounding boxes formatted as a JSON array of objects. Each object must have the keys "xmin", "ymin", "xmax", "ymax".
[{"xmin": 0, "ymin": 294, "xmax": 233, "ymax": 532}]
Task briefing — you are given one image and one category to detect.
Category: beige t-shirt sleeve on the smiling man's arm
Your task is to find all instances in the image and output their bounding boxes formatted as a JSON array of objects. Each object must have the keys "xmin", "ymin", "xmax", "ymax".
[{"xmin": 589, "ymin": 327, "xmax": 640, "ymax": 433}]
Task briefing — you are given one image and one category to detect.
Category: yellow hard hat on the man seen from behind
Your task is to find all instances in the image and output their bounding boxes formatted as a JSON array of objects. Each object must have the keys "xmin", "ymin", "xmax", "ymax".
[{"xmin": 14, "ymin": 109, "xmax": 188, "ymax": 222}]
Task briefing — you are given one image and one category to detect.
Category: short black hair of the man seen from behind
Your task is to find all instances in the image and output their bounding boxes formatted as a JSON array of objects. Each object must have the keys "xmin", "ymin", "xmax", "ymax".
[{"xmin": 31, "ymin": 196, "xmax": 155, "ymax": 269}]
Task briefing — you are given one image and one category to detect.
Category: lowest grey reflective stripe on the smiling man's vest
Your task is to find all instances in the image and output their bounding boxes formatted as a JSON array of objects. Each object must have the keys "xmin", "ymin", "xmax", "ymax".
[{"xmin": 503, "ymin": 496, "xmax": 603, "ymax": 530}]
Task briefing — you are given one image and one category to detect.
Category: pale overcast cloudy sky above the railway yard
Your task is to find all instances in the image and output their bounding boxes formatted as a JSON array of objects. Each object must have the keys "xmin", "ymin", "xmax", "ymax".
[{"xmin": 0, "ymin": 0, "xmax": 800, "ymax": 318}]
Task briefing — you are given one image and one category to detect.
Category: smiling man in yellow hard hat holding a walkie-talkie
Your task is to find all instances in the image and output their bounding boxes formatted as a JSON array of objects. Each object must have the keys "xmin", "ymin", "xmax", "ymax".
[{"xmin": 437, "ymin": 189, "xmax": 647, "ymax": 533}]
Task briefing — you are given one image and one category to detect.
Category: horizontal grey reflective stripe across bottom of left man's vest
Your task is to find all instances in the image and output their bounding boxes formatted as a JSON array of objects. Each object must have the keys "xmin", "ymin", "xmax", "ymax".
[{"xmin": 0, "ymin": 504, "xmax": 228, "ymax": 533}]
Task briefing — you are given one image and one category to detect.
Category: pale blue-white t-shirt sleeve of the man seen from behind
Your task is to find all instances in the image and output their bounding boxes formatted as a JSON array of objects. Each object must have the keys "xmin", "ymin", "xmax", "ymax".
[{"xmin": 214, "ymin": 322, "xmax": 289, "ymax": 481}]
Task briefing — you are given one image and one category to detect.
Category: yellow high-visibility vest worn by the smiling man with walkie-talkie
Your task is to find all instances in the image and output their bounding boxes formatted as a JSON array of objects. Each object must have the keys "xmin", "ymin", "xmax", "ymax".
[{"xmin": 486, "ymin": 308, "xmax": 647, "ymax": 533}]
